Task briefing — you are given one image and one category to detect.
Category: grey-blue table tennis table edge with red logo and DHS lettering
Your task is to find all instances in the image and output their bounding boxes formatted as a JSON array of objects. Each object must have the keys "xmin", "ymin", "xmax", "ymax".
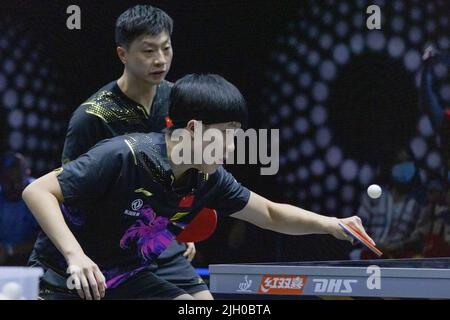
[{"xmin": 209, "ymin": 258, "xmax": 450, "ymax": 299}]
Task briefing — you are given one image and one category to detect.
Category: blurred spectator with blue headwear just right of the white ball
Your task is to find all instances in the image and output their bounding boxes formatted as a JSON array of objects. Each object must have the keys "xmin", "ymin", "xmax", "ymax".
[{"xmin": 350, "ymin": 149, "xmax": 426, "ymax": 260}]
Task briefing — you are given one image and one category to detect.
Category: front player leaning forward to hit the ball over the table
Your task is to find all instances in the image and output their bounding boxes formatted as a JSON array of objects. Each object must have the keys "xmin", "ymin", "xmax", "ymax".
[{"xmin": 23, "ymin": 74, "xmax": 370, "ymax": 300}]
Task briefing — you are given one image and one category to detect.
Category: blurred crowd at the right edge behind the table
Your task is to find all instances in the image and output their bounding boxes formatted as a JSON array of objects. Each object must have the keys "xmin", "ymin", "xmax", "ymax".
[{"xmin": 350, "ymin": 47, "xmax": 450, "ymax": 259}]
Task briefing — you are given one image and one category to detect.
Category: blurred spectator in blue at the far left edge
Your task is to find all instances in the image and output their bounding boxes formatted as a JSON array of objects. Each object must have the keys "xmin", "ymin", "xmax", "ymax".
[{"xmin": 0, "ymin": 152, "xmax": 39, "ymax": 265}]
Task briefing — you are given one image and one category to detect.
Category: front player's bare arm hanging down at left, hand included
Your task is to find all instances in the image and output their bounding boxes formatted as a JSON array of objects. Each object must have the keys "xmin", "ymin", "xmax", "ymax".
[{"xmin": 22, "ymin": 172, "xmax": 106, "ymax": 300}]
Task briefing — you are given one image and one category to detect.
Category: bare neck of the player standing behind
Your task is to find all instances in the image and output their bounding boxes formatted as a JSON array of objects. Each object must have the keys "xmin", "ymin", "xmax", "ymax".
[{"xmin": 117, "ymin": 71, "xmax": 156, "ymax": 114}]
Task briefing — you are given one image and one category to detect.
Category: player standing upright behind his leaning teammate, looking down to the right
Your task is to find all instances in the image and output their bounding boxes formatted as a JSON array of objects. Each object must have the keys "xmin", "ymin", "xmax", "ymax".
[{"xmin": 29, "ymin": 5, "xmax": 202, "ymax": 293}]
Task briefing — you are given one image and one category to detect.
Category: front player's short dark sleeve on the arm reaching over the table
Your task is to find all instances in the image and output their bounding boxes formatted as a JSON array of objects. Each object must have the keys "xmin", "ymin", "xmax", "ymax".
[{"xmin": 211, "ymin": 167, "xmax": 250, "ymax": 216}]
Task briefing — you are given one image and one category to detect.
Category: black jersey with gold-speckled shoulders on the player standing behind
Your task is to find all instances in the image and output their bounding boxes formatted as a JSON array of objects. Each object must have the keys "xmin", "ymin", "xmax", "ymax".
[{"xmin": 62, "ymin": 80, "xmax": 173, "ymax": 163}]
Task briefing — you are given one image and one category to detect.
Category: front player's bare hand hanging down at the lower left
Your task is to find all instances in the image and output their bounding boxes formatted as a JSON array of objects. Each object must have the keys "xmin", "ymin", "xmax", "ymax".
[{"xmin": 67, "ymin": 253, "xmax": 106, "ymax": 300}]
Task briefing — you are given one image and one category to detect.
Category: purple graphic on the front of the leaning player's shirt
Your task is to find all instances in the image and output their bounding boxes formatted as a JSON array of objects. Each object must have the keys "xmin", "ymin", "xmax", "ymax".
[{"xmin": 120, "ymin": 206, "xmax": 175, "ymax": 261}]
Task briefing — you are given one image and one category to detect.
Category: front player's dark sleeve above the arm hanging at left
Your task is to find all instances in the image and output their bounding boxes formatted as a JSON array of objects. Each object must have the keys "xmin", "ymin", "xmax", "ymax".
[{"xmin": 57, "ymin": 139, "xmax": 126, "ymax": 205}]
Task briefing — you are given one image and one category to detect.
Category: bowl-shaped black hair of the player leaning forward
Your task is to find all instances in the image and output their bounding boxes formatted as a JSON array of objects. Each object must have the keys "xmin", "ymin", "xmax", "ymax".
[{"xmin": 169, "ymin": 74, "xmax": 248, "ymax": 128}]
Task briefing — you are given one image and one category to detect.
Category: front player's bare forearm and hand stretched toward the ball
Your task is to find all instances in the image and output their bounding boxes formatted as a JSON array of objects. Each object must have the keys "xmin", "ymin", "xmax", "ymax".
[{"xmin": 231, "ymin": 192, "xmax": 375, "ymax": 244}]
